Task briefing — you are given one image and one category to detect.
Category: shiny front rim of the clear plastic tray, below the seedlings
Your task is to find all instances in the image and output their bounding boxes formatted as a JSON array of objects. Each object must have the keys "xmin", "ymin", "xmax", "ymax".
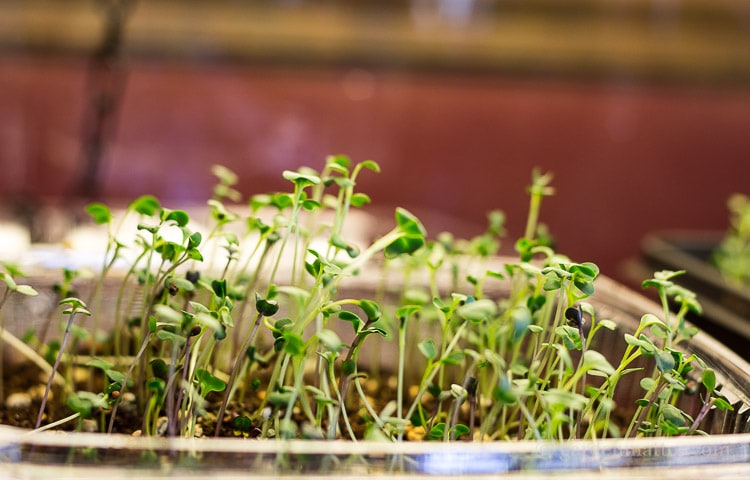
[{"xmin": 0, "ymin": 429, "xmax": 750, "ymax": 478}]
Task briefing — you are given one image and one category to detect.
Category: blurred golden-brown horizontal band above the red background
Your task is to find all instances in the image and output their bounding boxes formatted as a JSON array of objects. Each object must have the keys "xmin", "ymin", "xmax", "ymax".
[{"xmin": 0, "ymin": 0, "xmax": 750, "ymax": 84}]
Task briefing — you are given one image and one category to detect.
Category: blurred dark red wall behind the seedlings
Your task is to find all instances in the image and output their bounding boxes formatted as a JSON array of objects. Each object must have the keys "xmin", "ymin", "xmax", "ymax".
[{"xmin": 0, "ymin": 57, "xmax": 750, "ymax": 279}]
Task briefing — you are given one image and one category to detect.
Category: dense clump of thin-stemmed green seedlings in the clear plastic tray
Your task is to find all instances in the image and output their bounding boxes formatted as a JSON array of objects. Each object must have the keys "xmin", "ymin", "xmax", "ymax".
[{"xmin": 3, "ymin": 156, "xmax": 731, "ymax": 441}]
